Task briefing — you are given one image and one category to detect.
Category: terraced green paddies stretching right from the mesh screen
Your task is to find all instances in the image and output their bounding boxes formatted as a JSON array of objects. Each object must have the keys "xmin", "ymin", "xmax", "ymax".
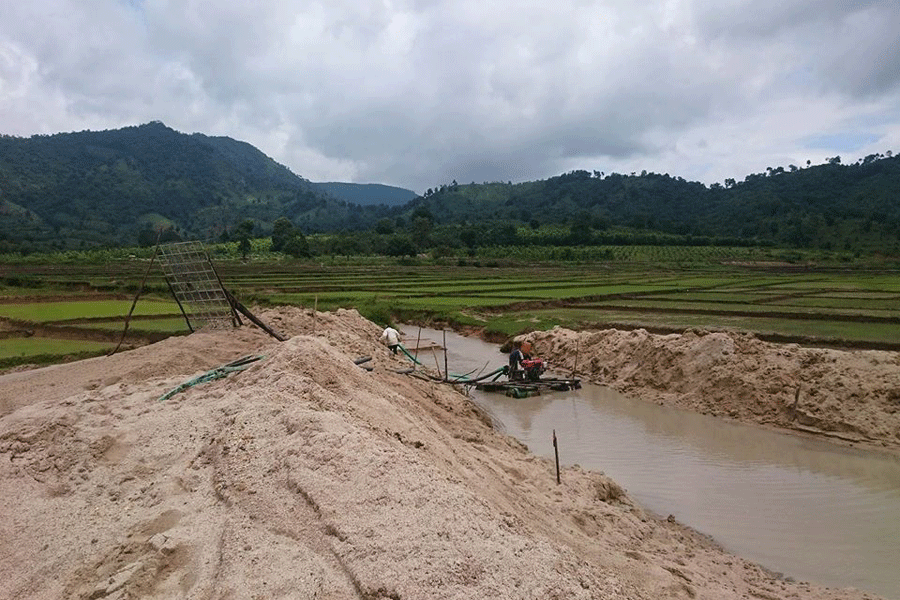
[{"xmin": 213, "ymin": 253, "xmax": 900, "ymax": 347}]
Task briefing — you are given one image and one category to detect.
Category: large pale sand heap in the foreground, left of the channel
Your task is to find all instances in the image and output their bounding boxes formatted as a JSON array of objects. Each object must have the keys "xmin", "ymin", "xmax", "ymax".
[{"xmin": 0, "ymin": 309, "xmax": 884, "ymax": 600}]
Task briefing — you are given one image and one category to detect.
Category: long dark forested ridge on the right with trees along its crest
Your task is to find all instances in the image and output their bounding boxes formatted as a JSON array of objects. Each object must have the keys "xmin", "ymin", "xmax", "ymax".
[{"xmin": 407, "ymin": 152, "xmax": 900, "ymax": 255}]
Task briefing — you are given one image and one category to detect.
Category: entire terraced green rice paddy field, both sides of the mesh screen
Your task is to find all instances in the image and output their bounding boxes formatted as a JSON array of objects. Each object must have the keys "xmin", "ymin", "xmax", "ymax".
[{"xmin": 0, "ymin": 249, "xmax": 900, "ymax": 368}]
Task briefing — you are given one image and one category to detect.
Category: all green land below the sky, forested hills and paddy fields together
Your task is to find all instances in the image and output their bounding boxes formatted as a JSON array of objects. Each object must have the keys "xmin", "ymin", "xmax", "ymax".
[{"xmin": 0, "ymin": 123, "xmax": 900, "ymax": 364}]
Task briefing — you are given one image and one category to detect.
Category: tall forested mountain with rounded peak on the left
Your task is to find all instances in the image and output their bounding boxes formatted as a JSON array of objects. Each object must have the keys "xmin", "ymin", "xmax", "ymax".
[{"xmin": 0, "ymin": 122, "xmax": 392, "ymax": 250}]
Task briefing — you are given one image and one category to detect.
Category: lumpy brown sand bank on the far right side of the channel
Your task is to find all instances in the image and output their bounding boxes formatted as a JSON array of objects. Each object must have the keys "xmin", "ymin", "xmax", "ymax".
[{"xmin": 528, "ymin": 328, "xmax": 900, "ymax": 449}]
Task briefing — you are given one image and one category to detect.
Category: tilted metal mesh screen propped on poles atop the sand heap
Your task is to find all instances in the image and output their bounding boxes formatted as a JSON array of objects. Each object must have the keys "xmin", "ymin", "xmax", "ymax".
[{"xmin": 159, "ymin": 242, "xmax": 236, "ymax": 330}]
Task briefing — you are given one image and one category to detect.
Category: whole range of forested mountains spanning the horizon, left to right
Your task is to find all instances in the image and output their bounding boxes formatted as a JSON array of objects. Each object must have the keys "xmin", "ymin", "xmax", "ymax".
[{"xmin": 0, "ymin": 122, "xmax": 900, "ymax": 256}]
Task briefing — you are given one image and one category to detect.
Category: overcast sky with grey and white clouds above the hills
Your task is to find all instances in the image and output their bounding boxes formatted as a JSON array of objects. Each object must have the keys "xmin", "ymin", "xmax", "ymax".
[{"xmin": 0, "ymin": 0, "xmax": 900, "ymax": 192}]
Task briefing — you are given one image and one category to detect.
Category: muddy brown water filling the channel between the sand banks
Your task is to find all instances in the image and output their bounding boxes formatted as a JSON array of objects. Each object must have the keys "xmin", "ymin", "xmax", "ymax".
[{"xmin": 406, "ymin": 327, "xmax": 900, "ymax": 600}]
